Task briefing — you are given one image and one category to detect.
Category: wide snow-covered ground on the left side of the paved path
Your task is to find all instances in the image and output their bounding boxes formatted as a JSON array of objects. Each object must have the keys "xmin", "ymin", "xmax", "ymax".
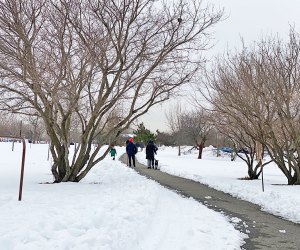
[{"xmin": 0, "ymin": 142, "xmax": 245, "ymax": 250}]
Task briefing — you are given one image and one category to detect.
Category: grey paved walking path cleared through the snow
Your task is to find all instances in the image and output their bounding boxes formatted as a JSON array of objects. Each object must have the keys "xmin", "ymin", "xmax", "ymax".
[{"xmin": 121, "ymin": 155, "xmax": 300, "ymax": 250}]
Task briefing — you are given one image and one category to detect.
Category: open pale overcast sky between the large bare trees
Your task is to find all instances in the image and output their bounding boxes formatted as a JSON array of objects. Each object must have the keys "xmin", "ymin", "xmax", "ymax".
[{"xmin": 141, "ymin": 0, "xmax": 300, "ymax": 132}]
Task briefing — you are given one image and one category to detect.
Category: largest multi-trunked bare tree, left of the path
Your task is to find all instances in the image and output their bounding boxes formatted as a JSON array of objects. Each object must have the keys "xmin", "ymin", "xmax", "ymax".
[{"xmin": 0, "ymin": 0, "xmax": 222, "ymax": 182}]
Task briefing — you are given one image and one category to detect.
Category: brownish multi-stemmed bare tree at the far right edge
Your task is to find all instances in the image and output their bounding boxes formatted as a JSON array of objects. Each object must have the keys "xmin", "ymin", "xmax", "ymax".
[{"xmin": 202, "ymin": 30, "xmax": 300, "ymax": 184}]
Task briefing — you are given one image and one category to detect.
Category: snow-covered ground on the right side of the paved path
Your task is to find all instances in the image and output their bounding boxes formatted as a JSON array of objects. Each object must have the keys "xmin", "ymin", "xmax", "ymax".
[{"xmin": 137, "ymin": 147, "xmax": 300, "ymax": 223}]
